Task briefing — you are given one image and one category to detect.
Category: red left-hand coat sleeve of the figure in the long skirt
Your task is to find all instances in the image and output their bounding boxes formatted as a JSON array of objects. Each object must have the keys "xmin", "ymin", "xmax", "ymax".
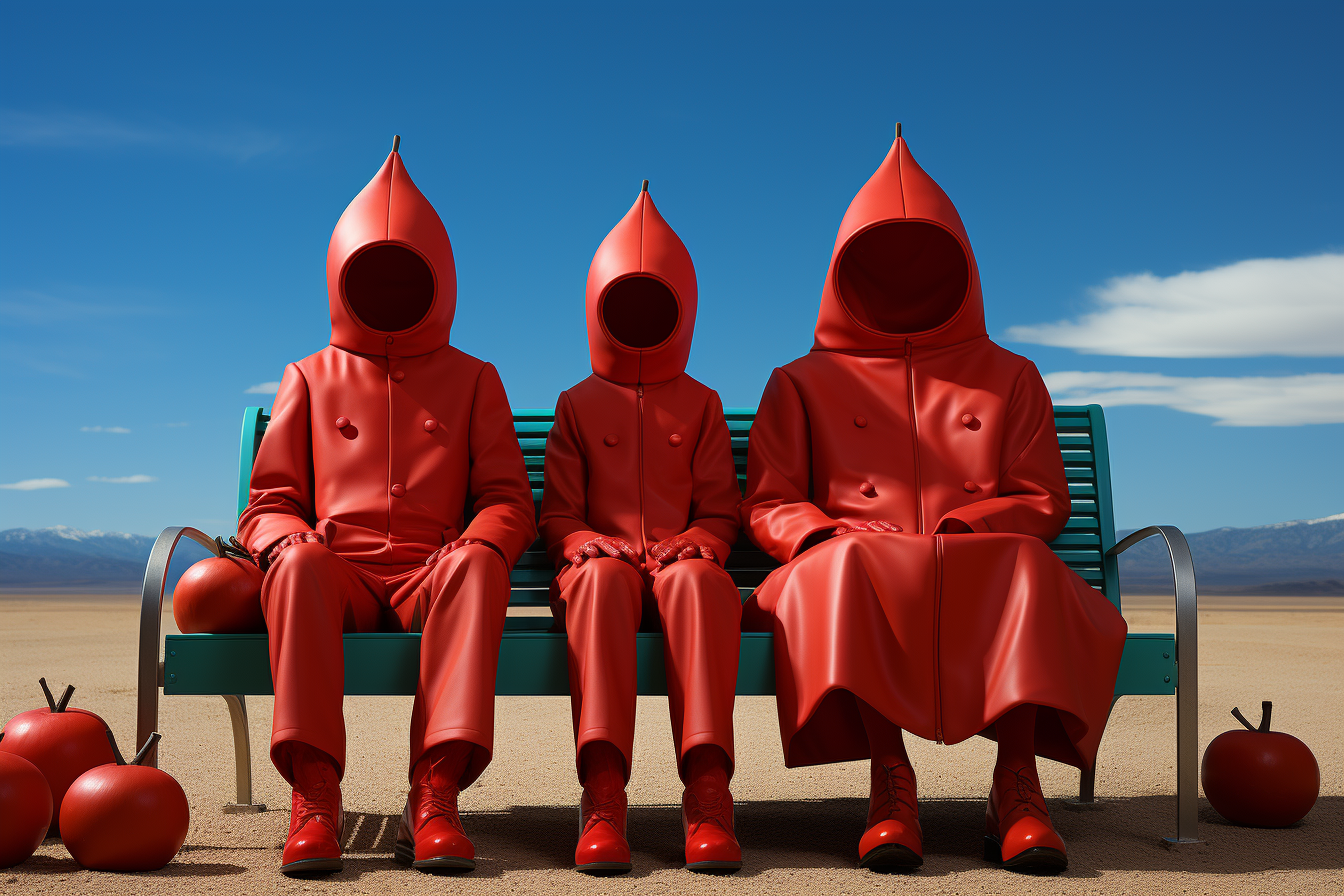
[{"xmin": 742, "ymin": 368, "xmax": 841, "ymax": 563}]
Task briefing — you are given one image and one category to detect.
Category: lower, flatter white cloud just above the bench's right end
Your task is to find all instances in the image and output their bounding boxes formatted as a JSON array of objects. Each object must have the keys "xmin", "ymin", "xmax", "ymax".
[{"xmin": 1046, "ymin": 371, "xmax": 1344, "ymax": 426}]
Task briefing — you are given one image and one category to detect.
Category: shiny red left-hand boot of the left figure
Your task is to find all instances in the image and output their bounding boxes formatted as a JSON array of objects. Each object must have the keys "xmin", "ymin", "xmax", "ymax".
[{"xmin": 280, "ymin": 750, "xmax": 345, "ymax": 875}]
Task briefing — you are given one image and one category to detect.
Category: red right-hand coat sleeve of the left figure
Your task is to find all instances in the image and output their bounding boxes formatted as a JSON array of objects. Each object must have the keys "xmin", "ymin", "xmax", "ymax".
[{"xmin": 462, "ymin": 364, "xmax": 536, "ymax": 567}]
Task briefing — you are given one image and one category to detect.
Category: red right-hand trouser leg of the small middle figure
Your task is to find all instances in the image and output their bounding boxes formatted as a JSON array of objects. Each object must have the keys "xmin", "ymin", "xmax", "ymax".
[{"xmin": 653, "ymin": 559, "xmax": 742, "ymax": 764}]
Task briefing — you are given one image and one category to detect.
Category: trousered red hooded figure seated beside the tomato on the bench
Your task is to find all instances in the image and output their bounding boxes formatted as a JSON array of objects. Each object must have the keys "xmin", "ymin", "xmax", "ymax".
[{"xmin": 238, "ymin": 144, "xmax": 536, "ymax": 872}]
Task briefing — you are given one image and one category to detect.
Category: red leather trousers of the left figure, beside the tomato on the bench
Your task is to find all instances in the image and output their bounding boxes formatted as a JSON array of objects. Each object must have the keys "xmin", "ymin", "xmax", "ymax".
[{"xmin": 261, "ymin": 544, "xmax": 509, "ymax": 786}]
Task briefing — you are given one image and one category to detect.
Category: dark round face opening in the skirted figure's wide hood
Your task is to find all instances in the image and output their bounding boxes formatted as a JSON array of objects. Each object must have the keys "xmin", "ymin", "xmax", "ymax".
[{"xmin": 836, "ymin": 220, "xmax": 970, "ymax": 334}]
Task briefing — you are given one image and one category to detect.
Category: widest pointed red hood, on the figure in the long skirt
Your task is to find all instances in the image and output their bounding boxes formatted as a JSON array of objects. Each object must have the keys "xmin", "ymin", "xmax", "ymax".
[{"xmin": 812, "ymin": 125, "xmax": 985, "ymax": 352}]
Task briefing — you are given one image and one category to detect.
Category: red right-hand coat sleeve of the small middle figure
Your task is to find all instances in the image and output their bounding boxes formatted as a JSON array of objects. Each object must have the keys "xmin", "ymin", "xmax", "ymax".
[{"xmin": 683, "ymin": 390, "xmax": 742, "ymax": 566}]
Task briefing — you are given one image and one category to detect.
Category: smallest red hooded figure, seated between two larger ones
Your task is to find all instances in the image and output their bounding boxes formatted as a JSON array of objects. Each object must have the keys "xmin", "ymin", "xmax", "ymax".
[{"xmin": 540, "ymin": 181, "xmax": 742, "ymax": 872}]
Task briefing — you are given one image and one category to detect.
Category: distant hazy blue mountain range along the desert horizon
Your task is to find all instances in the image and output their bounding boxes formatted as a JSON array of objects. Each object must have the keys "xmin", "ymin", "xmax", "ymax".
[{"xmin": 0, "ymin": 513, "xmax": 1344, "ymax": 595}]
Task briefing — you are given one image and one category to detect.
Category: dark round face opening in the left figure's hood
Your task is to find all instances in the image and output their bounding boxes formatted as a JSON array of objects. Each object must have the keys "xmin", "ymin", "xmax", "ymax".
[{"xmin": 343, "ymin": 243, "xmax": 434, "ymax": 333}]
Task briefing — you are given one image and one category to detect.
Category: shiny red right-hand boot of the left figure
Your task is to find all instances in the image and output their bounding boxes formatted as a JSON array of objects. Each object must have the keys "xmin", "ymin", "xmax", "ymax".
[{"xmin": 392, "ymin": 748, "xmax": 476, "ymax": 872}]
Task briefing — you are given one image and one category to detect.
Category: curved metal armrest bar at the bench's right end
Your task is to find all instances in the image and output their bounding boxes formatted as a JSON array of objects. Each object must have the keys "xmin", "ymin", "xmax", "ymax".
[{"xmin": 1106, "ymin": 525, "xmax": 1199, "ymax": 844}]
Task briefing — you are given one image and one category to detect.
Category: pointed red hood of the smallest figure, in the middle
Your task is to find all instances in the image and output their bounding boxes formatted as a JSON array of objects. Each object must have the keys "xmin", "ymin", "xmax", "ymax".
[{"xmin": 587, "ymin": 181, "xmax": 695, "ymax": 383}]
